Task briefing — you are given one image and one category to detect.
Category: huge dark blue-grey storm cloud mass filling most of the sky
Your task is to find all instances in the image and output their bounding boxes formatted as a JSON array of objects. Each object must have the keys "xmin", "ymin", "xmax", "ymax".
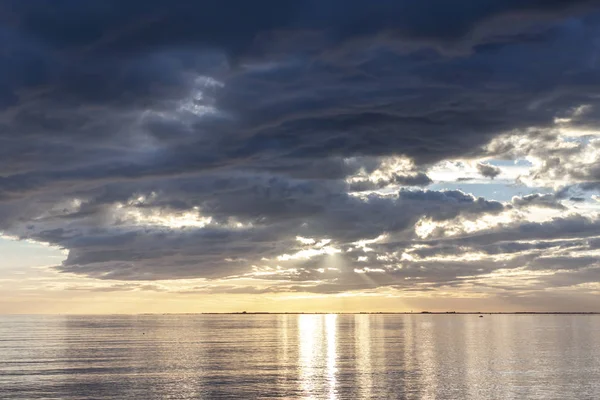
[{"xmin": 0, "ymin": 0, "xmax": 600, "ymax": 291}]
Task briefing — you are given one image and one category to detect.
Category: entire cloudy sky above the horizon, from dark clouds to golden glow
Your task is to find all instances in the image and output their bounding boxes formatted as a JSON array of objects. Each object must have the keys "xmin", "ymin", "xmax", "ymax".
[{"xmin": 0, "ymin": 0, "xmax": 600, "ymax": 313}]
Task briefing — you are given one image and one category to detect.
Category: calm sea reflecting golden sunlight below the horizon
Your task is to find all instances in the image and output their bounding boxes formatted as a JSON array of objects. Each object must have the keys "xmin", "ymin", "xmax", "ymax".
[{"xmin": 0, "ymin": 315, "xmax": 600, "ymax": 400}]
